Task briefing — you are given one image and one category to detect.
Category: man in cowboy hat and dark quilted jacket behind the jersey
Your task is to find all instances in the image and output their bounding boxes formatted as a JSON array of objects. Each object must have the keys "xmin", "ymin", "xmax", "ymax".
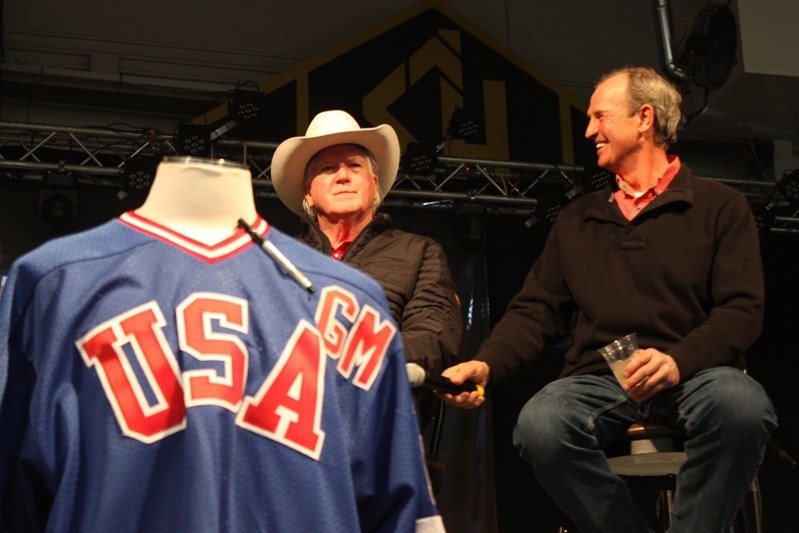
[{"xmin": 272, "ymin": 110, "xmax": 463, "ymax": 423}]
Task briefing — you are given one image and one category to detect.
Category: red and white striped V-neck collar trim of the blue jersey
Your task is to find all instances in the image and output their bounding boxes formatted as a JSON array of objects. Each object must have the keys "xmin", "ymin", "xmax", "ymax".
[{"xmin": 119, "ymin": 211, "xmax": 269, "ymax": 263}]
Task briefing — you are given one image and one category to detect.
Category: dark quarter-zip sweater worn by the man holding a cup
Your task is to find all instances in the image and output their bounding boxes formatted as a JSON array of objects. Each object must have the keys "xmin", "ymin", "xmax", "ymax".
[{"xmin": 475, "ymin": 165, "xmax": 764, "ymax": 382}]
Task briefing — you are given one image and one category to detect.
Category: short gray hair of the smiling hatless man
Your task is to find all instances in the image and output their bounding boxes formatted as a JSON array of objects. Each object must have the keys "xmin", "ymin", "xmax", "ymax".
[{"xmin": 596, "ymin": 67, "xmax": 682, "ymax": 148}]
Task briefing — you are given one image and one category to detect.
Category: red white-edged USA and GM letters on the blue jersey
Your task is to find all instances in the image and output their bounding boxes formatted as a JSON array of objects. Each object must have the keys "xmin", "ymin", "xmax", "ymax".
[{"xmin": 75, "ymin": 286, "xmax": 396, "ymax": 460}]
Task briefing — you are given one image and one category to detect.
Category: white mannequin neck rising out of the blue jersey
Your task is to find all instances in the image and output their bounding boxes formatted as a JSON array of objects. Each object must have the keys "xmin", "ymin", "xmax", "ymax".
[{"xmin": 136, "ymin": 158, "xmax": 257, "ymax": 245}]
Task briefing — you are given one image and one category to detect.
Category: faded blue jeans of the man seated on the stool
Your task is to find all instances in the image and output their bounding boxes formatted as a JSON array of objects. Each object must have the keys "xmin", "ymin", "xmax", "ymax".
[{"xmin": 513, "ymin": 367, "xmax": 777, "ymax": 533}]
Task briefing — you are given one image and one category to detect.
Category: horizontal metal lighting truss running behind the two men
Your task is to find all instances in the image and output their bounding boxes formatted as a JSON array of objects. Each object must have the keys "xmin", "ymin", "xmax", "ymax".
[{"xmin": 0, "ymin": 121, "xmax": 799, "ymax": 233}]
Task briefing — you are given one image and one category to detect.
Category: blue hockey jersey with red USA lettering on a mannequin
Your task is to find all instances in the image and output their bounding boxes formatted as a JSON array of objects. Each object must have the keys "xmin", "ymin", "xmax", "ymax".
[{"xmin": 0, "ymin": 212, "xmax": 443, "ymax": 533}]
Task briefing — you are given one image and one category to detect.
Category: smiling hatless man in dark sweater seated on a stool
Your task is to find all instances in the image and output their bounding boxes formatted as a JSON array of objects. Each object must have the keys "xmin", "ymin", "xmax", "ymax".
[{"xmin": 442, "ymin": 68, "xmax": 777, "ymax": 533}]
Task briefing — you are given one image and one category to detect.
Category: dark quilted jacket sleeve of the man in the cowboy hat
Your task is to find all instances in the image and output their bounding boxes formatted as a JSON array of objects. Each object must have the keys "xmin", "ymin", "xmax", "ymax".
[{"xmin": 400, "ymin": 241, "xmax": 463, "ymax": 374}]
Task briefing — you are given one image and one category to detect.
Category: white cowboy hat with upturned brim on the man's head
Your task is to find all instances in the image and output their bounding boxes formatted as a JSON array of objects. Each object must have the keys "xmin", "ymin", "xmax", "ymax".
[{"xmin": 272, "ymin": 109, "xmax": 400, "ymax": 214}]
